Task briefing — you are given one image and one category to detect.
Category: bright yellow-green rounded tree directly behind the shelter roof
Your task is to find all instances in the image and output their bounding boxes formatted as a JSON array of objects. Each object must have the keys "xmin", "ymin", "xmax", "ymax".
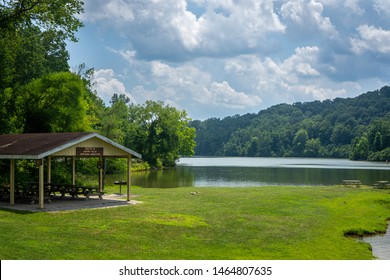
[{"xmin": 16, "ymin": 72, "xmax": 91, "ymax": 132}]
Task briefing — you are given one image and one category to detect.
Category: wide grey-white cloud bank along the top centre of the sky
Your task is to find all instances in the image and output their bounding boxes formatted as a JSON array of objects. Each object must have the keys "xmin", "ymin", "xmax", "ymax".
[{"xmin": 83, "ymin": 0, "xmax": 285, "ymax": 61}]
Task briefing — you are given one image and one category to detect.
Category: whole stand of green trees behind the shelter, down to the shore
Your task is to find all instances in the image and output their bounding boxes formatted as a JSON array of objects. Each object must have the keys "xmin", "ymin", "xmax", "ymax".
[{"xmin": 0, "ymin": 0, "xmax": 195, "ymax": 167}]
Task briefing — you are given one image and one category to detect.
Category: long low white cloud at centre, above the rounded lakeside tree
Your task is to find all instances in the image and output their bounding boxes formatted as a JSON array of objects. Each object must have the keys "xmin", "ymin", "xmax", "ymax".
[{"xmin": 132, "ymin": 61, "xmax": 261, "ymax": 109}]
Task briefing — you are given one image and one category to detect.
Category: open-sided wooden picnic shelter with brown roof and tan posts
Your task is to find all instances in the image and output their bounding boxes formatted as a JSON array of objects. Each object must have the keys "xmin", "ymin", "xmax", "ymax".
[{"xmin": 0, "ymin": 132, "xmax": 142, "ymax": 209}]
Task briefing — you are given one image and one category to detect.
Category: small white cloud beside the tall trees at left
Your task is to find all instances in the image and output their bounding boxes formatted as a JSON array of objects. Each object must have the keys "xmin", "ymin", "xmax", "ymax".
[{"xmin": 93, "ymin": 69, "xmax": 135, "ymax": 104}]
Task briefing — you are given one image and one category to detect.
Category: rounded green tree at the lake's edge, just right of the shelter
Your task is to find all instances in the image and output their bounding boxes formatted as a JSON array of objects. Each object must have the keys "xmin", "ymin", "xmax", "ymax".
[{"xmin": 125, "ymin": 101, "xmax": 195, "ymax": 167}]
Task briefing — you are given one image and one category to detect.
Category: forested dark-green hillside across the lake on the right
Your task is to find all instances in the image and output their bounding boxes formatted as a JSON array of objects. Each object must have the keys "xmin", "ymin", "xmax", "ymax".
[{"xmin": 191, "ymin": 86, "xmax": 390, "ymax": 160}]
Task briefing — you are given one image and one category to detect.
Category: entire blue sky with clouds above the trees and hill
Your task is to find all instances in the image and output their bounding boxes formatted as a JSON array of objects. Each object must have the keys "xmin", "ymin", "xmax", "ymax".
[{"xmin": 68, "ymin": 0, "xmax": 390, "ymax": 120}]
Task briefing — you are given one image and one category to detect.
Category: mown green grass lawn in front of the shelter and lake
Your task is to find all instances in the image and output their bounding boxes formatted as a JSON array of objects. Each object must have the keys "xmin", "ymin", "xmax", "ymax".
[{"xmin": 0, "ymin": 186, "xmax": 390, "ymax": 260}]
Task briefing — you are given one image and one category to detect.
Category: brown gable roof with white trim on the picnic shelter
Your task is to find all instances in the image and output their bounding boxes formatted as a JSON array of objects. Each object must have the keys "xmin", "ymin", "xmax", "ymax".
[{"xmin": 0, "ymin": 132, "xmax": 142, "ymax": 159}]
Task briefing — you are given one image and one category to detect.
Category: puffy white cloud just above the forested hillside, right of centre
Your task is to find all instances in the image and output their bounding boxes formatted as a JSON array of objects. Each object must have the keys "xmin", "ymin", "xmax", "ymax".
[{"xmin": 225, "ymin": 46, "xmax": 350, "ymax": 104}]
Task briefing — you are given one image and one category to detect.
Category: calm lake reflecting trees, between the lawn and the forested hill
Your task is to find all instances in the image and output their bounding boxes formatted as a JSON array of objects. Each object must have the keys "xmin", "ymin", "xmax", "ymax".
[{"xmin": 129, "ymin": 157, "xmax": 390, "ymax": 188}]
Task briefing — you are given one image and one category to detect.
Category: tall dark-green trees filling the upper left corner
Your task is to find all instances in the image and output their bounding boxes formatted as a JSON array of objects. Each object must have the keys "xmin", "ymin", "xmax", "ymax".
[{"xmin": 0, "ymin": 0, "xmax": 83, "ymax": 133}]
